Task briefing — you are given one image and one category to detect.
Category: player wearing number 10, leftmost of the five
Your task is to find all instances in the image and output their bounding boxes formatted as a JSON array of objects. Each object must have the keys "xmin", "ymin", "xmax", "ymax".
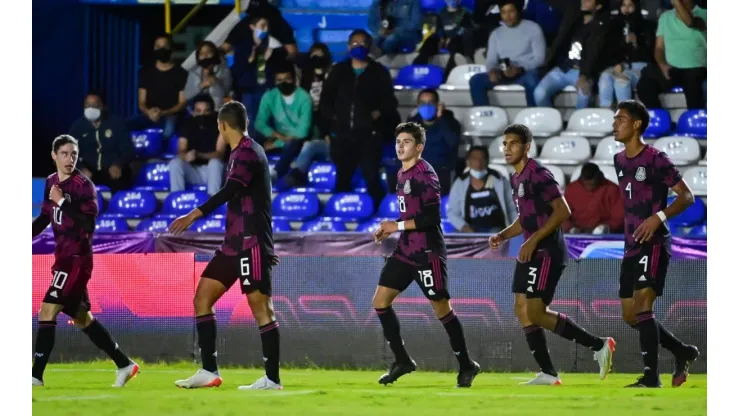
[{"xmin": 32, "ymin": 134, "xmax": 139, "ymax": 387}]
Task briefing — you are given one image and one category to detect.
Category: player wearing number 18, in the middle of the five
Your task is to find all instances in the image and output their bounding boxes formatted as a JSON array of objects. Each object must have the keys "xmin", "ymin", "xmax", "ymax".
[{"xmin": 373, "ymin": 123, "xmax": 481, "ymax": 387}]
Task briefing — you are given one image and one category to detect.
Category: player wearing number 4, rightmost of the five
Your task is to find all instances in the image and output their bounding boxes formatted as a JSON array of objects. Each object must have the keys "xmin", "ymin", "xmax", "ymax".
[{"xmin": 613, "ymin": 100, "xmax": 699, "ymax": 387}]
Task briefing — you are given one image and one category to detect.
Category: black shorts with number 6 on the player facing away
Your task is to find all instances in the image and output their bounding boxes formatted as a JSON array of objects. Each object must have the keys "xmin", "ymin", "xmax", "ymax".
[{"xmin": 200, "ymin": 246, "xmax": 272, "ymax": 296}]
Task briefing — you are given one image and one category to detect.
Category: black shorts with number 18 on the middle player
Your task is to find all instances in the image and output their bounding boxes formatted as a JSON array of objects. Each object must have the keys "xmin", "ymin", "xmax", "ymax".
[{"xmin": 378, "ymin": 254, "xmax": 450, "ymax": 300}]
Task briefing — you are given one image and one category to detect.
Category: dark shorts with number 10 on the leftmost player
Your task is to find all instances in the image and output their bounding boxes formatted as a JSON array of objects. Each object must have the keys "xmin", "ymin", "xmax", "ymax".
[{"xmin": 43, "ymin": 256, "xmax": 93, "ymax": 318}]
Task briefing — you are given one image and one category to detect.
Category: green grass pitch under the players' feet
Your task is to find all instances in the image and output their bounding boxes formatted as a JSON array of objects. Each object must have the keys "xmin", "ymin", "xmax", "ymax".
[{"xmin": 33, "ymin": 362, "xmax": 707, "ymax": 416}]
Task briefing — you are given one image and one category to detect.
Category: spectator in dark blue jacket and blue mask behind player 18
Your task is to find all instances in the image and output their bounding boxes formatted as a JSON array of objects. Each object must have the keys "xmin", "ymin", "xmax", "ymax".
[{"xmin": 408, "ymin": 88, "xmax": 462, "ymax": 195}]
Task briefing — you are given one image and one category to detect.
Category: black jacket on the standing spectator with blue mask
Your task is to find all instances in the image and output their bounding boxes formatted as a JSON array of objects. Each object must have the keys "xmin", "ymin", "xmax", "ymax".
[{"xmin": 319, "ymin": 59, "xmax": 400, "ymax": 138}]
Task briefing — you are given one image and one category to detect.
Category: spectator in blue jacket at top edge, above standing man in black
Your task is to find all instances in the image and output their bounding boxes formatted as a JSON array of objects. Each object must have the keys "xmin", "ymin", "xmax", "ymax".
[{"xmin": 367, "ymin": 0, "xmax": 422, "ymax": 54}]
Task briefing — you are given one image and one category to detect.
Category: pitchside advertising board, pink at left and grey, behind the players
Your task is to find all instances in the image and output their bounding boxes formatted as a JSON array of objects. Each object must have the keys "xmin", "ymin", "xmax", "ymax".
[{"xmin": 32, "ymin": 253, "xmax": 707, "ymax": 373}]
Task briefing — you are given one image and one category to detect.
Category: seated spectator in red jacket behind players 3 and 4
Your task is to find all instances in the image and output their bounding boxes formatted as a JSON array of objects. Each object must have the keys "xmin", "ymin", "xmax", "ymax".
[{"xmin": 563, "ymin": 163, "xmax": 624, "ymax": 234}]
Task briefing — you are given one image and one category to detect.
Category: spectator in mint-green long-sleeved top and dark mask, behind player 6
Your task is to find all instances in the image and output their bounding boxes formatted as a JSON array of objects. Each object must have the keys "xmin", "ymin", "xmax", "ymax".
[{"xmin": 255, "ymin": 61, "xmax": 313, "ymax": 180}]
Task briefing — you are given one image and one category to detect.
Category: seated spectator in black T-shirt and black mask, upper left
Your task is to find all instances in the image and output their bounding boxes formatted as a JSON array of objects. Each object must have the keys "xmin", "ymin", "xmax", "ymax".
[{"xmin": 128, "ymin": 35, "xmax": 188, "ymax": 140}]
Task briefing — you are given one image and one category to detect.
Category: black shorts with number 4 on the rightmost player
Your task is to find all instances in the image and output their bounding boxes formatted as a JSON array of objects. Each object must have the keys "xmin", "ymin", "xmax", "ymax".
[{"xmin": 619, "ymin": 243, "xmax": 671, "ymax": 298}]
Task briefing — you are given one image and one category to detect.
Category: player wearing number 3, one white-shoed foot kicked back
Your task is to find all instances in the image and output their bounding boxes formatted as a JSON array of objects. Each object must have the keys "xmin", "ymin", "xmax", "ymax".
[{"xmin": 489, "ymin": 124, "xmax": 616, "ymax": 385}]
